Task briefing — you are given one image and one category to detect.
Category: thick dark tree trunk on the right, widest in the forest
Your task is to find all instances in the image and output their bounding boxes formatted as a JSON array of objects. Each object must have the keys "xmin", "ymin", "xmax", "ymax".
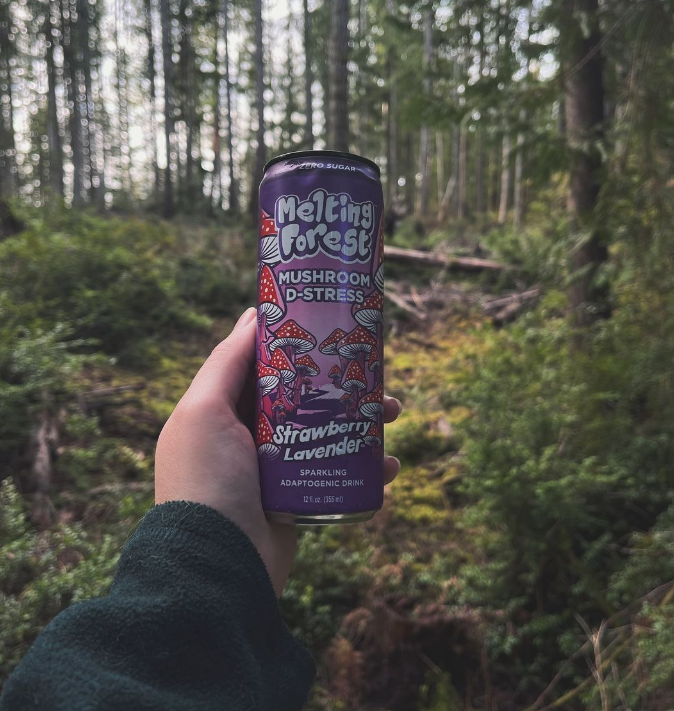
[{"xmin": 561, "ymin": 0, "xmax": 609, "ymax": 330}]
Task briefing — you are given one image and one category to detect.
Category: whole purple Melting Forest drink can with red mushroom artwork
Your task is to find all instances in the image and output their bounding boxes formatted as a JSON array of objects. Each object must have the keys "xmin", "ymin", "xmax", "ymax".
[{"xmin": 256, "ymin": 151, "xmax": 384, "ymax": 524}]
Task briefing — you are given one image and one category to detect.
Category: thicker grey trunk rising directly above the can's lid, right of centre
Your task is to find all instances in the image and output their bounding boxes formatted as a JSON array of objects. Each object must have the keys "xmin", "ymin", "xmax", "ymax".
[{"xmin": 327, "ymin": 0, "xmax": 349, "ymax": 151}]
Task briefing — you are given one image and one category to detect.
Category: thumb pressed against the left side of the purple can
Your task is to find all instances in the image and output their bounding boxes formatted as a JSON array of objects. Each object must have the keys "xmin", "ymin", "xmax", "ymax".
[{"xmin": 190, "ymin": 307, "xmax": 257, "ymax": 408}]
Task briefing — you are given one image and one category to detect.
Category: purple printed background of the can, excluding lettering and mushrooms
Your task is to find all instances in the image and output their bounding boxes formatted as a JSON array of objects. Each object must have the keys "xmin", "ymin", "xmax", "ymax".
[{"xmin": 256, "ymin": 153, "xmax": 384, "ymax": 516}]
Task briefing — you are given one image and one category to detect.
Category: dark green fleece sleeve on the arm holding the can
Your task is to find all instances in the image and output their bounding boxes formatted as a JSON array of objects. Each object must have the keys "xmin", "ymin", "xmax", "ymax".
[{"xmin": 0, "ymin": 501, "xmax": 315, "ymax": 711}]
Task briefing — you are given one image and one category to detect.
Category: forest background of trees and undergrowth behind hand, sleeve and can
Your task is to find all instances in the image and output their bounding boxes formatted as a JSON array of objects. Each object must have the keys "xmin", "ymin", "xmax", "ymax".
[{"xmin": 0, "ymin": 0, "xmax": 674, "ymax": 711}]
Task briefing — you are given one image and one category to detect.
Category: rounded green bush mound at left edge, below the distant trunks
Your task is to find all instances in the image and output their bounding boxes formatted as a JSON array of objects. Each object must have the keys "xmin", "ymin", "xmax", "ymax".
[{"xmin": 0, "ymin": 211, "xmax": 207, "ymax": 362}]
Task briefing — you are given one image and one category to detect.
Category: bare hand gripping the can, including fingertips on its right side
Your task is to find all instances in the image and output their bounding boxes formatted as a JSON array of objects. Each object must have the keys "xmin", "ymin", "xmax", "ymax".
[{"xmin": 155, "ymin": 308, "xmax": 401, "ymax": 595}]
